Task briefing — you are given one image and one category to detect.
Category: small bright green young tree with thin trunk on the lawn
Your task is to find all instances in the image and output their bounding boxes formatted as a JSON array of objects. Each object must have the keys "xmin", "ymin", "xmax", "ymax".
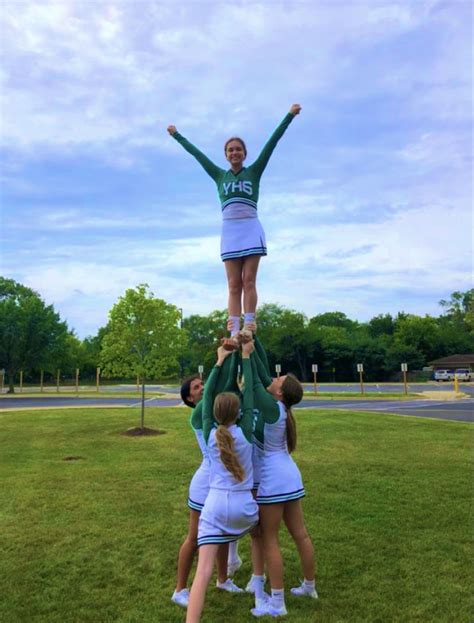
[{"xmin": 100, "ymin": 284, "xmax": 183, "ymax": 431}]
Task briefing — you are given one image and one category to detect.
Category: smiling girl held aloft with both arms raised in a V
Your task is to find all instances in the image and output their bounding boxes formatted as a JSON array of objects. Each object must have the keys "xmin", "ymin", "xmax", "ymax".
[{"xmin": 168, "ymin": 104, "xmax": 301, "ymax": 348}]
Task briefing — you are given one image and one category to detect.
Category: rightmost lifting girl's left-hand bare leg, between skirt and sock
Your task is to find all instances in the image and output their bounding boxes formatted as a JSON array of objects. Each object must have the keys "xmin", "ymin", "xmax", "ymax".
[{"xmin": 259, "ymin": 503, "xmax": 284, "ymax": 589}]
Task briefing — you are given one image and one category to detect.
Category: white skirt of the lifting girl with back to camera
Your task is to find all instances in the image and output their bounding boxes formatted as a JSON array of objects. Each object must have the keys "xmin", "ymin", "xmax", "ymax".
[{"xmin": 198, "ymin": 489, "xmax": 258, "ymax": 546}]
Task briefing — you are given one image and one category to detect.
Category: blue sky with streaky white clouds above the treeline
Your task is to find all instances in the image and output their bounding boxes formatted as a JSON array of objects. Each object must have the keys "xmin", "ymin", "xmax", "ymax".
[{"xmin": 0, "ymin": 0, "xmax": 472, "ymax": 338}]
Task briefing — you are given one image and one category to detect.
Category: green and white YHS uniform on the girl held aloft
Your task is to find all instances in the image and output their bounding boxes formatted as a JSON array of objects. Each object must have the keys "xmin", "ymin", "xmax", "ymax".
[{"xmin": 173, "ymin": 113, "xmax": 294, "ymax": 262}]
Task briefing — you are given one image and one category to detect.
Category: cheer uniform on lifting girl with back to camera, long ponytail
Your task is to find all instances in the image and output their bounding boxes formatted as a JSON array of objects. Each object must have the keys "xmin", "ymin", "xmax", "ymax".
[{"xmin": 198, "ymin": 359, "xmax": 258, "ymax": 546}]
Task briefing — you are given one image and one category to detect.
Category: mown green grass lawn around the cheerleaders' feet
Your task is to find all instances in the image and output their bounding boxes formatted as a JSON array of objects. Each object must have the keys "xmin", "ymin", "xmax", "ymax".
[{"xmin": 0, "ymin": 408, "xmax": 473, "ymax": 623}]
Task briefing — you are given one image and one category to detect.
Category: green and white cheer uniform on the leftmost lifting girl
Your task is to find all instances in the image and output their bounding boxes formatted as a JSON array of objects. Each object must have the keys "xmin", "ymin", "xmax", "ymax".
[{"xmin": 188, "ymin": 353, "xmax": 238, "ymax": 512}]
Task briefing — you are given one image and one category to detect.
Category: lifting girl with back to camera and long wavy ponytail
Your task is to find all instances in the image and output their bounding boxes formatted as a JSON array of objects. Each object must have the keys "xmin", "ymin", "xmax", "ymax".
[{"xmin": 186, "ymin": 342, "xmax": 258, "ymax": 623}]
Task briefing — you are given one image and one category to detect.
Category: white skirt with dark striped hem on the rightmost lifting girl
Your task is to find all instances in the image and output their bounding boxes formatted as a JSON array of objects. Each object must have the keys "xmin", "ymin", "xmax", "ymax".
[{"xmin": 257, "ymin": 452, "xmax": 305, "ymax": 504}]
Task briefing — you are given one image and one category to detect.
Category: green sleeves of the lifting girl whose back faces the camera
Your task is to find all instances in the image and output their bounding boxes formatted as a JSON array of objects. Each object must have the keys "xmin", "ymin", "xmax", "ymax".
[{"xmin": 202, "ymin": 358, "xmax": 253, "ymax": 443}]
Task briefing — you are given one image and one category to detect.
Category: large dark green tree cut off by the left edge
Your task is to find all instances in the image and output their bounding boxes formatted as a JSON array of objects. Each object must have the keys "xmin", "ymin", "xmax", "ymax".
[{"xmin": 0, "ymin": 277, "xmax": 68, "ymax": 393}]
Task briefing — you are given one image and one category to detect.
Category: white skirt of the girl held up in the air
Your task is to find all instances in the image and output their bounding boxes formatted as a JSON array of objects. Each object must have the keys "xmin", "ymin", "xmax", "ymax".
[{"xmin": 221, "ymin": 218, "xmax": 267, "ymax": 262}]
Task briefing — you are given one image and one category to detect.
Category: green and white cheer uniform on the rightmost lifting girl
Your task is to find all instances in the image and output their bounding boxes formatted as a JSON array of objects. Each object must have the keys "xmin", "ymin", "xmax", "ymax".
[{"xmin": 251, "ymin": 351, "xmax": 305, "ymax": 504}]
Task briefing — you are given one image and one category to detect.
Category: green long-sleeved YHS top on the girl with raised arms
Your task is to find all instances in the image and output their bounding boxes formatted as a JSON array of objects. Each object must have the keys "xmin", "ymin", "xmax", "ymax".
[{"xmin": 173, "ymin": 113, "xmax": 295, "ymax": 212}]
